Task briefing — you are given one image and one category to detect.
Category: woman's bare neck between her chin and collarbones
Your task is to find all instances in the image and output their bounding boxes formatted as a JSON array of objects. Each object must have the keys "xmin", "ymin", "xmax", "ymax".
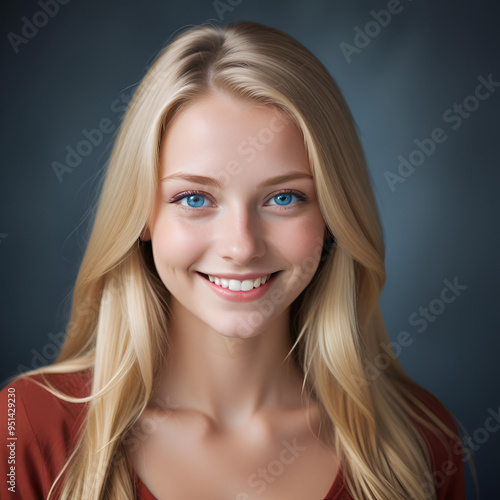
[{"xmin": 156, "ymin": 301, "xmax": 303, "ymax": 428}]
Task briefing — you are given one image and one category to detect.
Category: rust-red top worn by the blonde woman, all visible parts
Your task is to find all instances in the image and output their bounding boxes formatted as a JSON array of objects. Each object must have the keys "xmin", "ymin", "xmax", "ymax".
[{"xmin": 0, "ymin": 372, "xmax": 465, "ymax": 500}]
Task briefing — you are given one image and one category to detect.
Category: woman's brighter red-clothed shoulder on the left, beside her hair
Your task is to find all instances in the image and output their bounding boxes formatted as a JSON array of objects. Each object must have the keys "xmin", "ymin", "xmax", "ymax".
[{"xmin": 0, "ymin": 371, "xmax": 91, "ymax": 499}]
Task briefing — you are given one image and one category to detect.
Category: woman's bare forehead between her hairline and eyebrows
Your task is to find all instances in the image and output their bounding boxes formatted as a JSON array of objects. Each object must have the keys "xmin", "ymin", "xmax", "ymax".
[{"xmin": 160, "ymin": 94, "xmax": 310, "ymax": 181}]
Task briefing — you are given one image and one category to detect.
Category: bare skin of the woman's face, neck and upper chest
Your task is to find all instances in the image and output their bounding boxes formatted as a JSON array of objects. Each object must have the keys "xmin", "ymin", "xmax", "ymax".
[{"xmin": 131, "ymin": 94, "xmax": 338, "ymax": 500}]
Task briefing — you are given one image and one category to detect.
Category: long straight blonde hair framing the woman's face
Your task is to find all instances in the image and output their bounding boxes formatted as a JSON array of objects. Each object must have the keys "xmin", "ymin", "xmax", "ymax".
[{"xmin": 12, "ymin": 22, "xmax": 458, "ymax": 500}]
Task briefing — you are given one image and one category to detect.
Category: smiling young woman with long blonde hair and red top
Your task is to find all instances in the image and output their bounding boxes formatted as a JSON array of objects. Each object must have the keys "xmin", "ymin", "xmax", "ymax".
[{"xmin": 2, "ymin": 22, "xmax": 465, "ymax": 500}]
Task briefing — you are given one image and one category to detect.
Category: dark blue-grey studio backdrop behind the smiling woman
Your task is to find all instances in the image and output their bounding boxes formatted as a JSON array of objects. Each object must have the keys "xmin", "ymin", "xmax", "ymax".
[{"xmin": 0, "ymin": 0, "xmax": 500, "ymax": 499}]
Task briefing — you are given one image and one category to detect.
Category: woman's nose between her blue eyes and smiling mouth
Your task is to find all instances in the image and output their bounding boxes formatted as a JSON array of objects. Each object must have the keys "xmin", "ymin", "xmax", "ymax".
[{"xmin": 218, "ymin": 207, "xmax": 266, "ymax": 266}]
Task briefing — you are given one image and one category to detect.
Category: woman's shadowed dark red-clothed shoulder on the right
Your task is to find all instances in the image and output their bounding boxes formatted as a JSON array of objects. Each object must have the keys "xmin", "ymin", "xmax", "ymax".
[{"xmin": 412, "ymin": 387, "xmax": 467, "ymax": 500}]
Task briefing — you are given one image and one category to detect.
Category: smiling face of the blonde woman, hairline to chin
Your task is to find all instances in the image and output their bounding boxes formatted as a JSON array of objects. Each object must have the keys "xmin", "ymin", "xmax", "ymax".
[{"xmin": 148, "ymin": 94, "xmax": 325, "ymax": 338}]
